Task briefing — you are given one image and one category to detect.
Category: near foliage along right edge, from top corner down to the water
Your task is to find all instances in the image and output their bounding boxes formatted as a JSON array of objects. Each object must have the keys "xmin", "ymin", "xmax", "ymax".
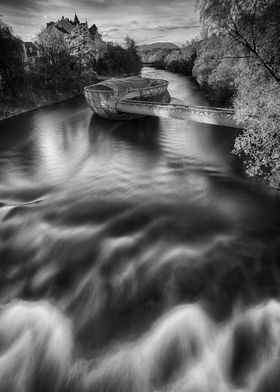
[{"xmin": 198, "ymin": 0, "xmax": 280, "ymax": 188}]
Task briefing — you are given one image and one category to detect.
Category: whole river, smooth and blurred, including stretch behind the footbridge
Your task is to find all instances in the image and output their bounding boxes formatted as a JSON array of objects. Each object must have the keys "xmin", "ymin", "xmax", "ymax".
[{"xmin": 0, "ymin": 68, "xmax": 280, "ymax": 392}]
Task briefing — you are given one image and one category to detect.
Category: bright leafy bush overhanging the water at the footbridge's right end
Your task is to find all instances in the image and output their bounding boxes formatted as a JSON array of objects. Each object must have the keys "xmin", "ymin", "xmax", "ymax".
[{"xmin": 234, "ymin": 64, "xmax": 280, "ymax": 188}]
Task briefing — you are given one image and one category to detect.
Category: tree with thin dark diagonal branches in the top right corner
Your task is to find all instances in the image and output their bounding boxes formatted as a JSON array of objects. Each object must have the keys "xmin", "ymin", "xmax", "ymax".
[{"xmin": 197, "ymin": 0, "xmax": 280, "ymax": 83}]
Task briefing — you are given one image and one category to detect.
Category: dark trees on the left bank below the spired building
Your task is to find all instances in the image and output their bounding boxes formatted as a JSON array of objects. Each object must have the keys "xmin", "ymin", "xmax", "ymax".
[{"xmin": 0, "ymin": 15, "xmax": 141, "ymax": 117}]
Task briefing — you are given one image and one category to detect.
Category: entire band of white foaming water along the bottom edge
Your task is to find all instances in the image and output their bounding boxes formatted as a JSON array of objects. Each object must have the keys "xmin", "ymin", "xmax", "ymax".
[{"xmin": 0, "ymin": 301, "xmax": 280, "ymax": 392}]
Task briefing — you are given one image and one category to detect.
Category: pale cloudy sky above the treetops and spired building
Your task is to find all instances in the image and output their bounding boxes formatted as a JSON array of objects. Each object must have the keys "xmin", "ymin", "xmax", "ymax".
[{"xmin": 0, "ymin": 0, "xmax": 201, "ymax": 45}]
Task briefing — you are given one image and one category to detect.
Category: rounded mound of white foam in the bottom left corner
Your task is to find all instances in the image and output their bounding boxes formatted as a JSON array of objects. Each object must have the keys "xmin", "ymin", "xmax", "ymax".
[{"xmin": 0, "ymin": 301, "xmax": 73, "ymax": 392}]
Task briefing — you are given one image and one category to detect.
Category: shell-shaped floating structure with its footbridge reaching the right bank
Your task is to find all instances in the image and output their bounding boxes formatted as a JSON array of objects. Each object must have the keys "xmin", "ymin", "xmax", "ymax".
[{"xmin": 84, "ymin": 77, "xmax": 242, "ymax": 128}]
